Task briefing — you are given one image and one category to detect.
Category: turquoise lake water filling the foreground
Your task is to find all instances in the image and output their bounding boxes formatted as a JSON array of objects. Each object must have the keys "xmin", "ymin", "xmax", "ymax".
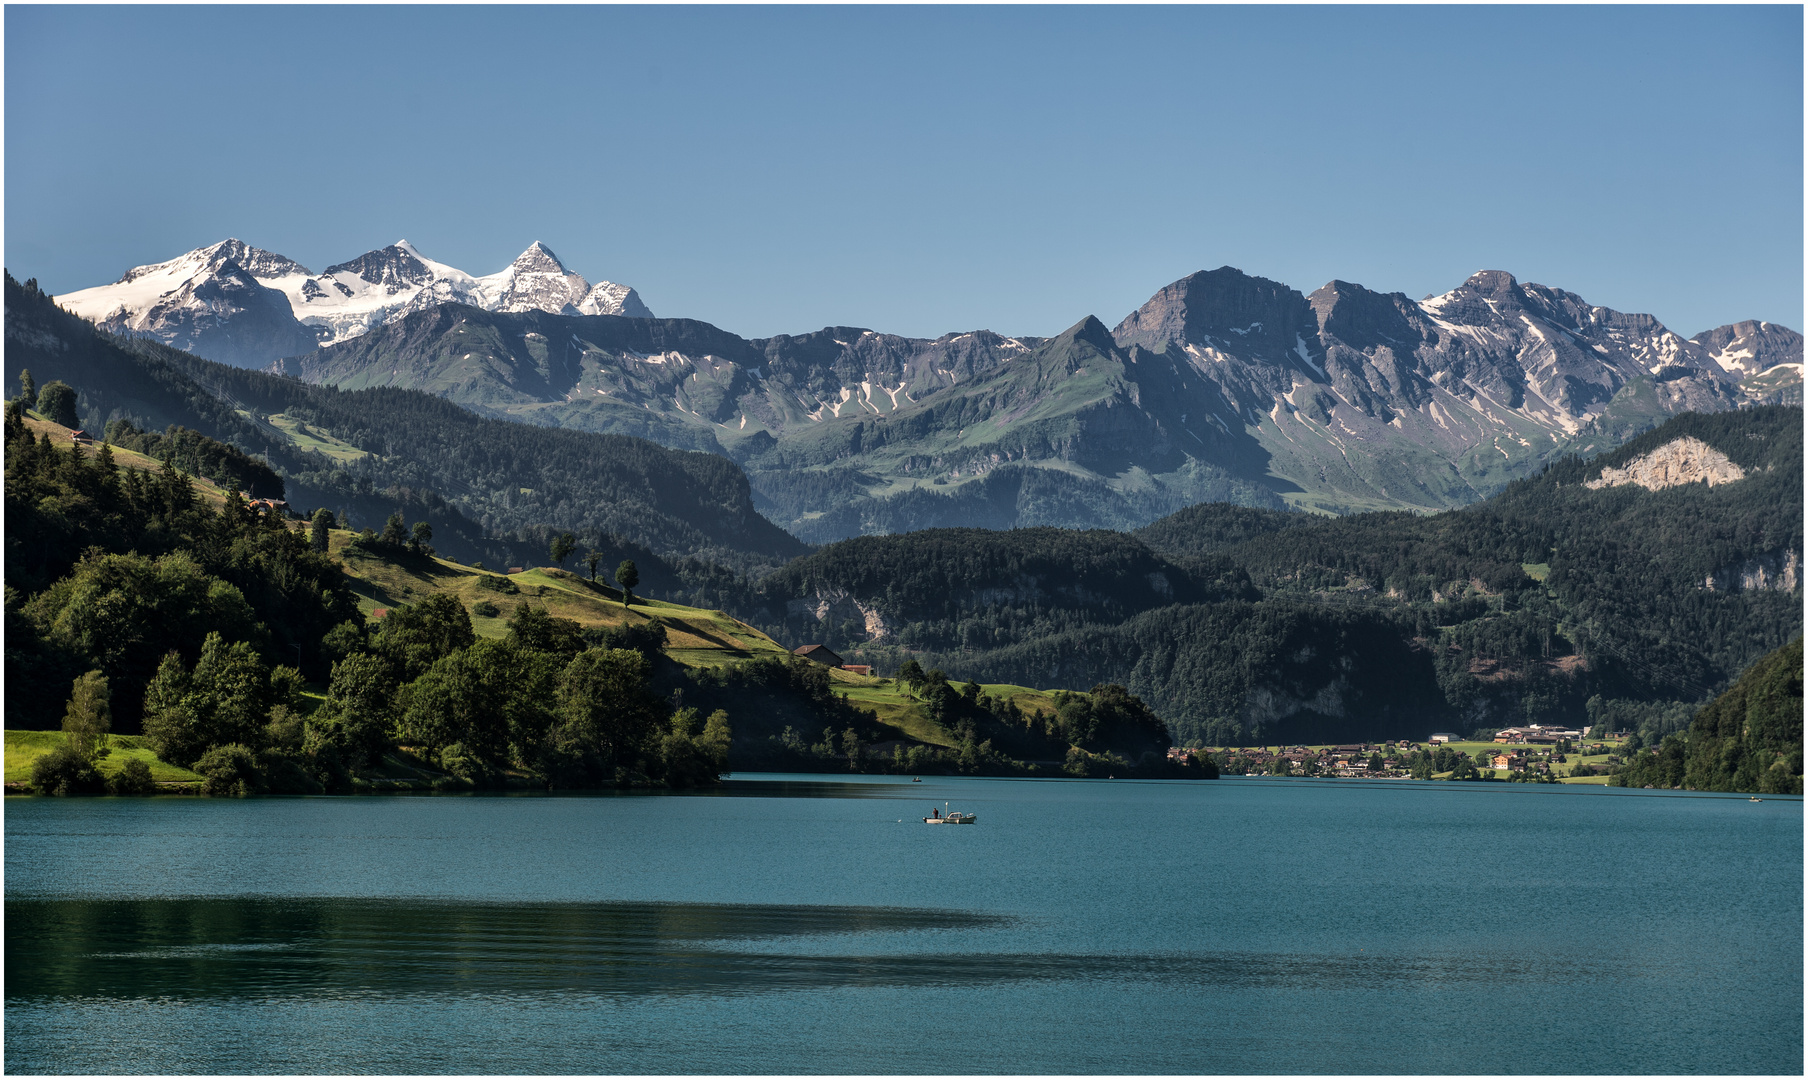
[{"xmin": 5, "ymin": 776, "xmax": 1803, "ymax": 1073}]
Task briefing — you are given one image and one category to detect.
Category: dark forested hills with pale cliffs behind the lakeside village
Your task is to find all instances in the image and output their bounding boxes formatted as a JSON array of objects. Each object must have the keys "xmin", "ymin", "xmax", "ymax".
[{"xmin": 761, "ymin": 407, "xmax": 1803, "ymax": 744}]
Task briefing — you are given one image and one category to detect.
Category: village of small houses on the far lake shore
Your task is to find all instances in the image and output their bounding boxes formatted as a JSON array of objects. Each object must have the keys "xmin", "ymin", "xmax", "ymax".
[{"xmin": 1168, "ymin": 724, "xmax": 1631, "ymax": 783}]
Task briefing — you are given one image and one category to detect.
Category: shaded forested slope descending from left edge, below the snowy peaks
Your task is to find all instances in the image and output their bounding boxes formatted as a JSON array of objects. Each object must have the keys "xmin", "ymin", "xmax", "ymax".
[{"xmin": 5, "ymin": 275, "xmax": 806, "ymax": 599}]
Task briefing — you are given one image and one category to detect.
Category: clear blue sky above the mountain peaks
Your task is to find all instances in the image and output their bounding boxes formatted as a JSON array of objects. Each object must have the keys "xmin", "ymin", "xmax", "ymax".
[{"xmin": 5, "ymin": 5, "xmax": 1803, "ymax": 336}]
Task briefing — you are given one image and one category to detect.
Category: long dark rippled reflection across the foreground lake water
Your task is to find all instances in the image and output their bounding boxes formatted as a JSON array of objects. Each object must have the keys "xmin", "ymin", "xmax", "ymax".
[{"xmin": 5, "ymin": 897, "xmax": 1624, "ymax": 1004}]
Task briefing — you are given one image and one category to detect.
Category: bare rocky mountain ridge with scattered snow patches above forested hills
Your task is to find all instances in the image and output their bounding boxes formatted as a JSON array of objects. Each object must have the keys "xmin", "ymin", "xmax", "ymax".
[{"xmin": 263, "ymin": 268, "xmax": 1801, "ymax": 541}]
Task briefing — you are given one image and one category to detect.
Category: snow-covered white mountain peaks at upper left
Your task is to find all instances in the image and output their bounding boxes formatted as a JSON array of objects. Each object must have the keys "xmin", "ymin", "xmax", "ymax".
[{"xmin": 56, "ymin": 239, "xmax": 653, "ymax": 367}]
